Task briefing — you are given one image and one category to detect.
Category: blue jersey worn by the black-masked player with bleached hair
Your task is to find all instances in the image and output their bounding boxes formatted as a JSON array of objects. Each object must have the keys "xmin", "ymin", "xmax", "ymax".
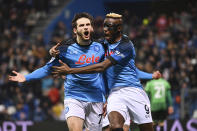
[{"xmin": 104, "ymin": 36, "xmax": 143, "ymax": 89}]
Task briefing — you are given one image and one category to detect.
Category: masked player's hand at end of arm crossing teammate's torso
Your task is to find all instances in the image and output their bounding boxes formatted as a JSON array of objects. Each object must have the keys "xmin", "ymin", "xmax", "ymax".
[{"xmin": 52, "ymin": 60, "xmax": 70, "ymax": 77}]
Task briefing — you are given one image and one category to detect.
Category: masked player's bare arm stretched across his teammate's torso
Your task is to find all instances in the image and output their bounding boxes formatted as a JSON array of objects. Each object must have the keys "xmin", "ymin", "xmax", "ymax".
[{"xmin": 52, "ymin": 59, "xmax": 113, "ymax": 76}]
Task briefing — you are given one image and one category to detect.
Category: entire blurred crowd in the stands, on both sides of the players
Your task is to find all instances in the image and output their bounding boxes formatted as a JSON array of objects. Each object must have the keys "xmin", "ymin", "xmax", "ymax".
[{"xmin": 0, "ymin": 0, "xmax": 197, "ymax": 121}]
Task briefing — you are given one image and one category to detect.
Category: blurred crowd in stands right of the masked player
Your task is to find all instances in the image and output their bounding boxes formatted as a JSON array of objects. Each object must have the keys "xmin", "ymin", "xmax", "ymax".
[{"xmin": 124, "ymin": 3, "xmax": 197, "ymax": 119}]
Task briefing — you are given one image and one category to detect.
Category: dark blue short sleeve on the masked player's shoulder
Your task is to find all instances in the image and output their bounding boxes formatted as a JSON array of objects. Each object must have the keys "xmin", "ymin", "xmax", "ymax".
[{"xmin": 108, "ymin": 41, "xmax": 134, "ymax": 65}]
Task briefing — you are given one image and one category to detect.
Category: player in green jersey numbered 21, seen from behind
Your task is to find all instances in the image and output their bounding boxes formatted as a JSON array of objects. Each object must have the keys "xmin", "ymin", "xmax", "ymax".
[{"xmin": 145, "ymin": 78, "xmax": 174, "ymax": 131}]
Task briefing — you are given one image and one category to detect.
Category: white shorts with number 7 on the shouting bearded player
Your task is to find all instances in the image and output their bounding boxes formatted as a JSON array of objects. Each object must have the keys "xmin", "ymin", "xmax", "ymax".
[{"xmin": 64, "ymin": 98, "xmax": 103, "ymax": 131}]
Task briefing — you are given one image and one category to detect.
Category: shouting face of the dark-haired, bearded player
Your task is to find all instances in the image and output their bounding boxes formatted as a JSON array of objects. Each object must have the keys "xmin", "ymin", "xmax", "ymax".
[{"xmin": 74, "ymin": 18, "xmax": 93, "ymax": 41}]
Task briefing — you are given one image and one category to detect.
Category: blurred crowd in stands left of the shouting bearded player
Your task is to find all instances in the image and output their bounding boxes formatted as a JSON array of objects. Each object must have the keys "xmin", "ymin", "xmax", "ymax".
[{"xmin": 0, "ymin": 0, "xmax": 63, "ymax": 121}]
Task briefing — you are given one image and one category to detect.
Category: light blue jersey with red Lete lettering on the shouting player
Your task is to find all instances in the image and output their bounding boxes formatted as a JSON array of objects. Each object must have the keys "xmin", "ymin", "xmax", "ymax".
[{"xmin": 25, "ymin": 42, "xmax": 105, "ymax": 102}]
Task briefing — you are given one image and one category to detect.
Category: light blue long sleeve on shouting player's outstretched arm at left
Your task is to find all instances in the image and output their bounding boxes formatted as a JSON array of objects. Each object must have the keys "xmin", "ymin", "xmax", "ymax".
[{"xmin": 25, "ymin": 57, "xmax": 59, "ymax": 81}]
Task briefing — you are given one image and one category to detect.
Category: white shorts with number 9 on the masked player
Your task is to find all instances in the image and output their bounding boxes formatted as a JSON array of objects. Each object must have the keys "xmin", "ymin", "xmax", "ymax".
[{"xmin": 107, "ymin": 87, "xmax": 152, "ymax": 124}]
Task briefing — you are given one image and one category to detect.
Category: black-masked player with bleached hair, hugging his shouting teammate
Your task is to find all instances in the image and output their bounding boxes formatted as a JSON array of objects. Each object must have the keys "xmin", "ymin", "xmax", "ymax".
[{"xmin": 53, "ymin": 13, "xmax": 161, "ymax": 131}]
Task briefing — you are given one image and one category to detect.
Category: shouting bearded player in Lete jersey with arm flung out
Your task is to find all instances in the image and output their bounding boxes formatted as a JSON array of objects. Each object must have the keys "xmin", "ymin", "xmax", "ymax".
[{"xmin": 9, "ymin": 13, "xmax": 105, "ymax": 131}]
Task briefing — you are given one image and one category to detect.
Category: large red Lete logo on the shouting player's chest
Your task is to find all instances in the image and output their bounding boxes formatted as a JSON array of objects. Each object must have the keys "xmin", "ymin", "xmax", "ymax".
[{"xmin": 75, "ymin": 54, "xmax": 99, "ymax": 65}]
